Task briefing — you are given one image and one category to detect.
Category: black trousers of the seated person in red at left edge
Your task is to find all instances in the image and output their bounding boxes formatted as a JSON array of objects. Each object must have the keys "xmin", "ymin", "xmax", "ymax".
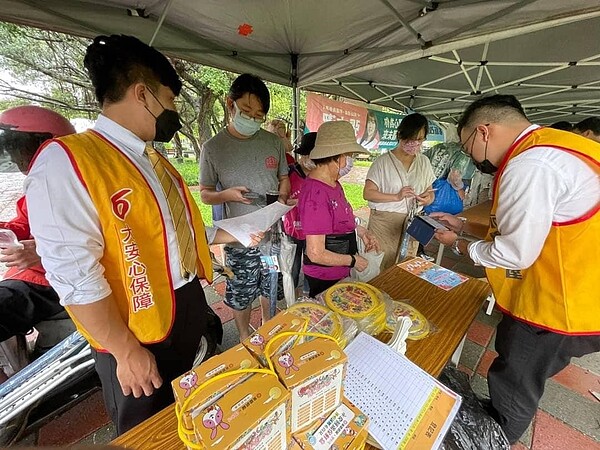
[{"xmin": 0, "ymin": 280, "xmax": 64, "ymax": 342}]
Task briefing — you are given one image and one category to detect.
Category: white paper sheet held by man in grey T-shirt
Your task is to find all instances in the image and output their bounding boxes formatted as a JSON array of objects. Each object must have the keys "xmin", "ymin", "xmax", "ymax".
[{"xmin": 213, "ymin": 202, "xmax": 294, "ymax": 247}]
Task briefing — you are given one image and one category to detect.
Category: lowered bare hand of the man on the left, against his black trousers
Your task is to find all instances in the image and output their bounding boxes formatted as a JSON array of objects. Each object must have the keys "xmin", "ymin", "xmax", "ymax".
[{"xmin": 114, "ymin": 344, "xmax": 162, "ymax": 398}]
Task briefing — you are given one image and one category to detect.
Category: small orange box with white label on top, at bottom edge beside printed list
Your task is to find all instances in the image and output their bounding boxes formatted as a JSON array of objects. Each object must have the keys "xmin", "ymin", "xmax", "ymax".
[{"xmin": 293, "ymin": 397, "xmax": 369, "ymax": 450}]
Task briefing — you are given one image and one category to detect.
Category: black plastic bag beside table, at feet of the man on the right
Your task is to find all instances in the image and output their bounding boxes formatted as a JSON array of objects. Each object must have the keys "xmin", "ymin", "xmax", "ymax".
[{"xmin": 439, "ymin": 366, "xmax": 510, "ymax": 450}]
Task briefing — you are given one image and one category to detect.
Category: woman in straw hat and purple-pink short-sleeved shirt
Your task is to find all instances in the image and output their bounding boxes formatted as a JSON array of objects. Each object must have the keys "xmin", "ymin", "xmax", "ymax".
[{"xmin": 298, "ymin": 121, "xmax": 378, "ymax": 297}]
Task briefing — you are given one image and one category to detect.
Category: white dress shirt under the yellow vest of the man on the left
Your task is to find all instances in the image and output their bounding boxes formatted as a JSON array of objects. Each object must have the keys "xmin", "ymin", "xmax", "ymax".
[{"xmin": 25, "ymin": 115, "xmax": 191, "ymax": 305}]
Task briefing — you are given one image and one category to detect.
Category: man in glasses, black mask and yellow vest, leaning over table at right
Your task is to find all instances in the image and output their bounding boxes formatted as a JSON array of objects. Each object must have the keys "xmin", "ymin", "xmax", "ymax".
[{"xmin": 432, "ymin": 95, "xmax": 600, "ymax": 443}]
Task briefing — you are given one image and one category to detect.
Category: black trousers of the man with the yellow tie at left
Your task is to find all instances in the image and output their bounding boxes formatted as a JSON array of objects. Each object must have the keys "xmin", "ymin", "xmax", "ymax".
[{"xmin": 92, "ymin": 278, "xmax": 217, "ymax": 435}]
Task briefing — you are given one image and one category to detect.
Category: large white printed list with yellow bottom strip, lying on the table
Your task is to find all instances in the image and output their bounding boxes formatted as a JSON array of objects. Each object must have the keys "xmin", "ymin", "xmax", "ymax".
[{"xmin": 344, "ymin": 333, "xmax": 462, "ymax": 450}]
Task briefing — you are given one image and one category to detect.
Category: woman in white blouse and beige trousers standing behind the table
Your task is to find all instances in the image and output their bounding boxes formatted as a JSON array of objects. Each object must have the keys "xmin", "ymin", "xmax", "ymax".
[{"xmin": 363, "ymin": 114, "xmax": 435, "ymax": 271}]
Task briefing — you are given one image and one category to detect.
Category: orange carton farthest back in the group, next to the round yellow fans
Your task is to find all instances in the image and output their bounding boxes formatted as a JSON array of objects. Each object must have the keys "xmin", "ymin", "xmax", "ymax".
[{"xmin": 243, "ymin": 310, "xmax": 308, "ymax": 366}]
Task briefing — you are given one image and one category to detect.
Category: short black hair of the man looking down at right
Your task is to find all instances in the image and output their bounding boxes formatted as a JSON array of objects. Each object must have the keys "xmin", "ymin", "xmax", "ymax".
[{"xmin": 457, "ymin": 94, "xmax": 527, "ymax": 136}]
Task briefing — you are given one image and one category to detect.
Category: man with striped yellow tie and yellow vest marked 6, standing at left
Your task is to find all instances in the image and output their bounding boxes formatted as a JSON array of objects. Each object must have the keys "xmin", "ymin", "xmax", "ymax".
[{"xmin": 25, "ymin": 35, "xmax": 220, "ymax": 434}]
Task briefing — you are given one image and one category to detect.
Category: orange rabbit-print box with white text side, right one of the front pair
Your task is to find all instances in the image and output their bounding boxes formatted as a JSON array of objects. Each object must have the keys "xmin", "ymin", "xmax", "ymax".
[{"xmin": 272, "ymin": 338, "xmax": 347, "ymax": 433}]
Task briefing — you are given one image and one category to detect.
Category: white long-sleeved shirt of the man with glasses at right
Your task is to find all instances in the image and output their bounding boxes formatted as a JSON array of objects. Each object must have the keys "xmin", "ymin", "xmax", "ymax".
[{"xmin": 469, "ymin": 125, "xmax": 600, "ymax": 269}]
